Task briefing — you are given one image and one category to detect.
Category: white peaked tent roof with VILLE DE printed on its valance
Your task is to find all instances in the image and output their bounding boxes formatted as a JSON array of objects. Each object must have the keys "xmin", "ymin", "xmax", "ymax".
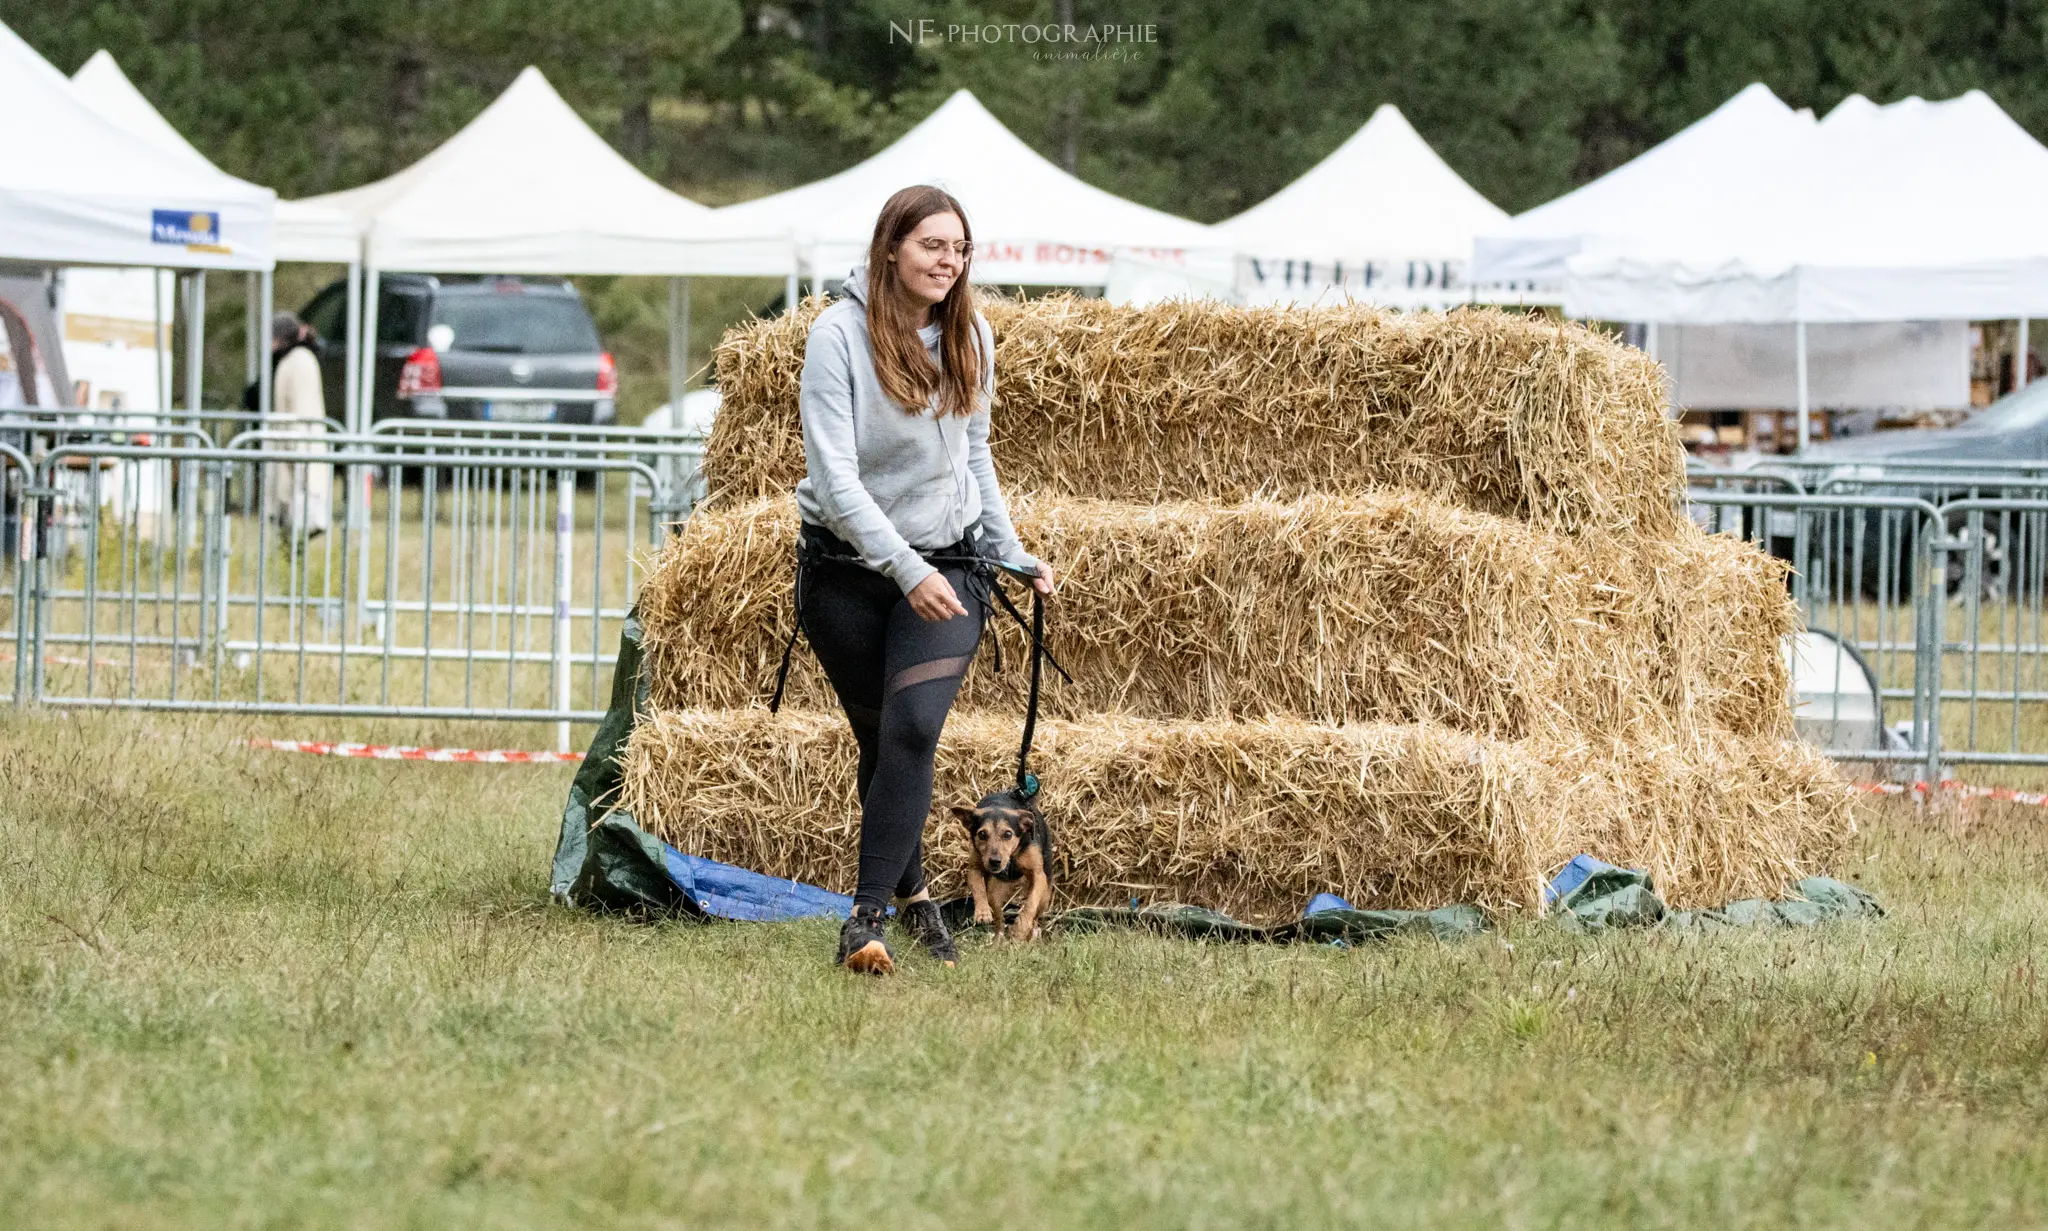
[{"xmin": 1212, "ymin": 104, "xmax": 1531, "ymax": 307}]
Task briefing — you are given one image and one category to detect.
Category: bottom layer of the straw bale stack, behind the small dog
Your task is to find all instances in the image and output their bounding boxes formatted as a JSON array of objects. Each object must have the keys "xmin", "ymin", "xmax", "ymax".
[{"xmin": 623, "ymin": 711, "xmax": 1851, "ymax": 920}]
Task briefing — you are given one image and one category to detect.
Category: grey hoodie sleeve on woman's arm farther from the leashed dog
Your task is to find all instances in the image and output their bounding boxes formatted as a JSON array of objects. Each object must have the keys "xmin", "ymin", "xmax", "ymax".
[{"xmin": 797, "ymin": 321, "xmax": 938, "ymax": 594}]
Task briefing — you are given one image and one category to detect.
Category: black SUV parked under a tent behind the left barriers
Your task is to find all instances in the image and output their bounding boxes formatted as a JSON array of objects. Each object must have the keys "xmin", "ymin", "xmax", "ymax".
[{"xmin": 299, "ymin": 274, "xmax": 618, "ymax": 424}]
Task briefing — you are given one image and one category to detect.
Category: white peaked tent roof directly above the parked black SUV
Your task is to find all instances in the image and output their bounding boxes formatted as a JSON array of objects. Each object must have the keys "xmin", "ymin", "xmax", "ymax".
[{"xmin": 307, "ymin": 68, "xmax": 793, "ymax": 274}]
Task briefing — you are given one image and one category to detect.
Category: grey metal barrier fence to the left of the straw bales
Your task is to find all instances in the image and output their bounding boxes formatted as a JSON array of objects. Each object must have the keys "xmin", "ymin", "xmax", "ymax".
[{"xmin": 0, "ymin": 428, "xmax": 694, "ymax": 748}]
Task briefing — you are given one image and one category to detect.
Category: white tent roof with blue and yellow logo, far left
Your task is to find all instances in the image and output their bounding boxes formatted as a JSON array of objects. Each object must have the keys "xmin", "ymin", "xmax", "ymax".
[{"xmin": 0, "ymin": 25, "xmax": 276, "ymax": 270}]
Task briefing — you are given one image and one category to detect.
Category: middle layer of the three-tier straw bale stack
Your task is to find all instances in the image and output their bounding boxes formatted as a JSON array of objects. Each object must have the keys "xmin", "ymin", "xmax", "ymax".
[{"xmin": 641, "ymin": 492, "xmax": 1792, "ymax": 739}]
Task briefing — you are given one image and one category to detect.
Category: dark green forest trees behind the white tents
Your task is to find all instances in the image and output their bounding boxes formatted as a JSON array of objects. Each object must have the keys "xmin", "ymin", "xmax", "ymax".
[{"xmin": 12, "ymin": 0, "xmax": 2048, "ymax": 410}]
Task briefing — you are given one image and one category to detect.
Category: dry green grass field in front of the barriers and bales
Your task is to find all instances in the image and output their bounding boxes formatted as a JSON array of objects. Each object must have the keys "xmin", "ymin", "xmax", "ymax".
[{"xmin": 0, "ymin": 715, "xmax": 2048, "ymax": 1227}]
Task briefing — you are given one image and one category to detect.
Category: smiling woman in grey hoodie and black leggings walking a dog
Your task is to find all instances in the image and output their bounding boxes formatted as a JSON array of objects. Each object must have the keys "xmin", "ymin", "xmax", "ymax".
[{"xmin": 797, "ymin": 186, "xmax": 1053, "ymax": 975}]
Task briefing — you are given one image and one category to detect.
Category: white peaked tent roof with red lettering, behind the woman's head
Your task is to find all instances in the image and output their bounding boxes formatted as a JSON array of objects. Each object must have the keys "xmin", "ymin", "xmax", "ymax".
[{"xmin": 719, "ymin": 90, "xmax": 1214, "ymax": 287}]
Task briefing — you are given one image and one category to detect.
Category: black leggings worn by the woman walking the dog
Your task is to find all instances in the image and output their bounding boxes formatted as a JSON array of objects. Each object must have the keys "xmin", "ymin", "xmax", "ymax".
[{"xmin": 801, "ymin": 532, "xmax": 985, "ymax": 907}]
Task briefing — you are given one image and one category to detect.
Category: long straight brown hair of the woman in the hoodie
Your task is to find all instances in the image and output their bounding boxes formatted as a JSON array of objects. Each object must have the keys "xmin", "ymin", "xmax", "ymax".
[{"xmin": 868, "ymin": 184, "xmax": 991, "ymax": 414}]
